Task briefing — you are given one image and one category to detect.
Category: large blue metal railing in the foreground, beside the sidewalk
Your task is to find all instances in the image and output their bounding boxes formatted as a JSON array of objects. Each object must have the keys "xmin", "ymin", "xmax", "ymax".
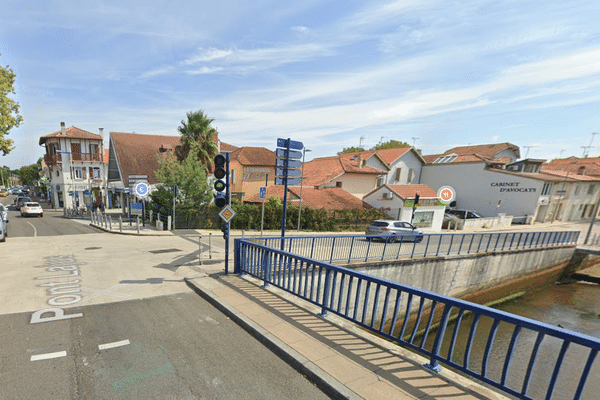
[{"xmin": 235, "ymin": 234, "xmax": 600, "ymax": 400}]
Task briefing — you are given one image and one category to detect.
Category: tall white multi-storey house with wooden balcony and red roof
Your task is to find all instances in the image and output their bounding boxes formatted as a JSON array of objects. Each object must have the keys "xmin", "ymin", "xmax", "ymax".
[{"xmin": 39, "ymin": 122, "xmax": 106, "ymax": 208}]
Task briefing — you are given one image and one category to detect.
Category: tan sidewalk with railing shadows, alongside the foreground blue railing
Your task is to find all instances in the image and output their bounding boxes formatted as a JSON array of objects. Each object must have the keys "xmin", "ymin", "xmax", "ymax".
[{"xmin": 186, "ymin": 274, "xmax": 507, "ymax": 400}]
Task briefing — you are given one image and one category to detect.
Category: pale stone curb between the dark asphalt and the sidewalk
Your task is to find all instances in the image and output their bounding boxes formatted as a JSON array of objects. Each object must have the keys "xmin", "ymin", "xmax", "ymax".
[{"xmin": 184, "ymin": 276, "xmax": 362, "ymax": 399}]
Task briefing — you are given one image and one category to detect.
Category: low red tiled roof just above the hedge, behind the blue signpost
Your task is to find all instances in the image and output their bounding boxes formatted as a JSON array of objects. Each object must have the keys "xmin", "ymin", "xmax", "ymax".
[{"xmin": 244, "ymin": 185, "xmax": 372, "ymax": 210}]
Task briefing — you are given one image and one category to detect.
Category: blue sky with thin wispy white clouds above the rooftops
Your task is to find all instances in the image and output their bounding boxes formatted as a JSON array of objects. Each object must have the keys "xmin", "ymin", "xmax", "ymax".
[{"xmin": 0, "ymin": 0, "xmax": 600, "ymax": 168}]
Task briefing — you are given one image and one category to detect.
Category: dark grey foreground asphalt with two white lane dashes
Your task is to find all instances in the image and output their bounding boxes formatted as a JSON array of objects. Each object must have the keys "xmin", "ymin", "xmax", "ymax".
[{"xmin": 0, "ymin": 293, "xmax": 327, "ymax": 399}]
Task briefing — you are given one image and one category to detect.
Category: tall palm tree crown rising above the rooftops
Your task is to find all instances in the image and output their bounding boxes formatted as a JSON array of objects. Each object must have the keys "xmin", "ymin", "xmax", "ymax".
[{"xmin": 175, "ymin": 110, "xmax": 219, "ymax": 172}]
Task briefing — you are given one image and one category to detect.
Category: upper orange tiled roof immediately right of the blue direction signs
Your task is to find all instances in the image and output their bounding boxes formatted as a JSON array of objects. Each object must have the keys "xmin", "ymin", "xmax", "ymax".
[{"xmin": 304, "ymin": 156, "xmax": 385, "ymax": 186}]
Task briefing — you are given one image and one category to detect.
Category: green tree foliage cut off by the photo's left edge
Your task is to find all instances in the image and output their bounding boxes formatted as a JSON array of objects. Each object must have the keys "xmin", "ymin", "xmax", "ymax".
[{"xmin": 0, "ymin": 54, "xmax": 23, "ymax": 155}]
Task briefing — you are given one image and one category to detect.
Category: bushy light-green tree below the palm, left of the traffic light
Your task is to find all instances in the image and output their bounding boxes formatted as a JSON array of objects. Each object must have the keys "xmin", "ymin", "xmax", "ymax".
[{"xmin": 155, "ymin": 142, "xmax": 213, "ymax": 210}]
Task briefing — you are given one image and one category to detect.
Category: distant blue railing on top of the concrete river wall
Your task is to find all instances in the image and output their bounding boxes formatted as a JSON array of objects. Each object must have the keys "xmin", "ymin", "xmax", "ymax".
[{"xmin": 246, "ymin": 231, "xmax": 579, "ymax": 264}]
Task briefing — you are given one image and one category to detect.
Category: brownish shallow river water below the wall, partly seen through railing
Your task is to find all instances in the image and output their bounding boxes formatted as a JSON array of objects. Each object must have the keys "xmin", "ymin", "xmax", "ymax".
[{"xmin": 432, "ymin": 276, "xmax": 600, "ymax": 400}]
